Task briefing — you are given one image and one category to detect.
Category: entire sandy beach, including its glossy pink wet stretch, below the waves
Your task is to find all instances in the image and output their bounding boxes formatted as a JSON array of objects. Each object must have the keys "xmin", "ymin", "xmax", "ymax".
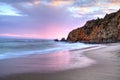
[{"xmin": 0, "ymin": 43, "xmax": 120, "ymax": 80}]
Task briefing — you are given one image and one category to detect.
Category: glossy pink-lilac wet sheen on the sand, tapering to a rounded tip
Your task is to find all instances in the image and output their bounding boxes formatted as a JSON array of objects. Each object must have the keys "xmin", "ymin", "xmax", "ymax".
[{"xmin": 0, "ymin": 51, "xmax": 94, "ymax": 75}]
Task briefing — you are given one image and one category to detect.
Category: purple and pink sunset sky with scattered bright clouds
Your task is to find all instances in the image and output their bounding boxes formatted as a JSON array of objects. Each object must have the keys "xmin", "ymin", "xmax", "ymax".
[{"xmin": 0, "ymin": 0, "xmax": 120, "ymax": 39}]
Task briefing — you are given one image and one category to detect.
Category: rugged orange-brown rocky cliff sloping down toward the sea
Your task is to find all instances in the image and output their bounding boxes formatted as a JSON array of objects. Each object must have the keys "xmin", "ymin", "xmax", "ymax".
[{"xmin": 67, "ymin": 10, "xmax": 120, "ymax": 43}]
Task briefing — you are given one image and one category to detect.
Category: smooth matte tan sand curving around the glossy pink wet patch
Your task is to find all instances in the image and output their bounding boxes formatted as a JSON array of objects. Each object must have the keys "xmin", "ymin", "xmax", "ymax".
[{"xmin": 0, "ymin": 43, "xmax": 120, "ymax": 80}]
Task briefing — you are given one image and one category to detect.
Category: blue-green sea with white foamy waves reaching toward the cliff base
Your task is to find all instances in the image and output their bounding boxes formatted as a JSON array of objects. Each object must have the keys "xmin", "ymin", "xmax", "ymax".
[{"xmin": 0, "ymin": 38, "xmax": 98, "ymax": 60}]
